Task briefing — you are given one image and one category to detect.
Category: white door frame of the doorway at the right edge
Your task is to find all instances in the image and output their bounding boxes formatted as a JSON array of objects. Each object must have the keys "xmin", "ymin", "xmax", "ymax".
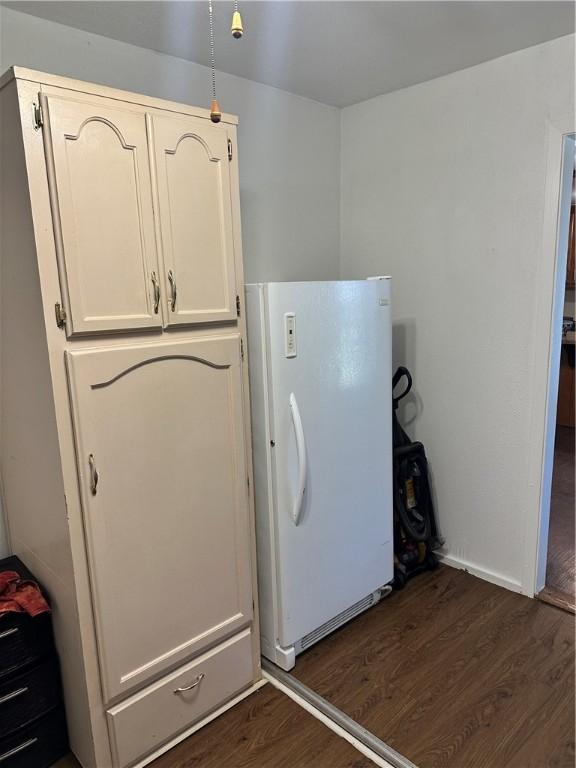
[{"xmin": 522, "ymin": 123, "xmax": 576, "ymax": 597}]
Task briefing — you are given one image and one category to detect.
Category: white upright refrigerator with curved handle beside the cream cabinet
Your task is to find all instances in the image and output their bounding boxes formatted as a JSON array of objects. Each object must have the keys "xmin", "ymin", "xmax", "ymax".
[{"xmin": 246, "ymin": 278, "xmax": 393, "ymax": 670}]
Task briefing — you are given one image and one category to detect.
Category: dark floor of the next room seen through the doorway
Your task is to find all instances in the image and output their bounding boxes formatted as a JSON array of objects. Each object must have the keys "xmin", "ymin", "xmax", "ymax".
[{"xmin": 540, "ymin": 427, "xmax": 576, "ymax": 611}]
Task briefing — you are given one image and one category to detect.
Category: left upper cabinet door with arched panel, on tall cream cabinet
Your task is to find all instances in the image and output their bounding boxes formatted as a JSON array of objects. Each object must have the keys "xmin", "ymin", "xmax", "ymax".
[{"xmin": 41, "ymin": 91, "xmax": 162, "ymax": 335}]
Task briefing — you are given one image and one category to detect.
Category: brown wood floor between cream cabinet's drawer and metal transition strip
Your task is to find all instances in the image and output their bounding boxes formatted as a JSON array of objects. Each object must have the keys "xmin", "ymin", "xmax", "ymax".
[{"xmin": 54, "ymin": 685, "xmax": 374, "ymax": 768}]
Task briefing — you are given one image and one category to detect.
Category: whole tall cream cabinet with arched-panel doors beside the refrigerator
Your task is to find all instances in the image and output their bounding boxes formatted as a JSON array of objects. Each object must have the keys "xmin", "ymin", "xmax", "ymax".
[{"xmin": 0, "ymin": 68, "xmax": 260, "ymax": 768}]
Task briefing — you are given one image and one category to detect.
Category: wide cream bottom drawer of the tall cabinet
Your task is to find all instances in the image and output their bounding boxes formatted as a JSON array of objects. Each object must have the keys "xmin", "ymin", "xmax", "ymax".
[{"xmin": 107, "ymin": 630, "xmax": 253, "ymax": 767}]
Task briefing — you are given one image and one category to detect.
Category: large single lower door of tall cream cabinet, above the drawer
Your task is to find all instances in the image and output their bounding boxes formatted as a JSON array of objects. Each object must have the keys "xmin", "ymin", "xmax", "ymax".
[{"xmin": 66, "ymin": 335, "xmax": 253, "ymax": 701}]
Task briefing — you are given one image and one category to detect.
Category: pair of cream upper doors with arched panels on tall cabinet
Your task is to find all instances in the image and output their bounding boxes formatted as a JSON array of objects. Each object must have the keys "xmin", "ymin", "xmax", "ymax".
[{"xmin": 40, "ymin": 89, "xmax": 238, "ymax": 336}]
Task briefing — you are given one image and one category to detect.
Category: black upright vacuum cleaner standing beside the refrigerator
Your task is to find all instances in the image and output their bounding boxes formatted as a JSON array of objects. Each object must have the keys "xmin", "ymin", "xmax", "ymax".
[{"xmin": 392, "ymin": 366, "xmax": 441, "ymax": 589}]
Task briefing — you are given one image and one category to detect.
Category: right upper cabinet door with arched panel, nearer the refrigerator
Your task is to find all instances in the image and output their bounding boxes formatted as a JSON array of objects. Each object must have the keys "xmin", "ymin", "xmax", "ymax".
[{"xmin": 149, "ymin": 115, "xmax": 236, "ymax": 325}]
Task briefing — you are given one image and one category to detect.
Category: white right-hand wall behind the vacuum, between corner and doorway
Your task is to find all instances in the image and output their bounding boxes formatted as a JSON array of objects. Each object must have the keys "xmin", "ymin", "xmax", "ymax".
[{"xmin": 341, "ymin": 36, "xmax": 574, "ymax": 592}]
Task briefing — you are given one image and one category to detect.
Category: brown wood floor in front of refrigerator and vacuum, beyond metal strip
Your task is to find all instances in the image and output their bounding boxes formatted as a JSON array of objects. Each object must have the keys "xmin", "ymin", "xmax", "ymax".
[{"xmin": 294, "ymin": 567, "xmax": 575, "ymax": 768}]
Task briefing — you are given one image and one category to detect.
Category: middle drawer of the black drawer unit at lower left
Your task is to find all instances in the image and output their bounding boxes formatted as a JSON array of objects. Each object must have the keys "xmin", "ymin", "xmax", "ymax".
[{"xmin": 0, "ymin": 656, "xmax": 62, "ymax": 738}]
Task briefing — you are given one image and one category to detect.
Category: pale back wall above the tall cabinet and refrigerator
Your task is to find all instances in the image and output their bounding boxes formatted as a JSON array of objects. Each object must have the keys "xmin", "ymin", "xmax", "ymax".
[{"xmin": 0, "ymin": 7, "xmax": 340, "ymax": 557}]
